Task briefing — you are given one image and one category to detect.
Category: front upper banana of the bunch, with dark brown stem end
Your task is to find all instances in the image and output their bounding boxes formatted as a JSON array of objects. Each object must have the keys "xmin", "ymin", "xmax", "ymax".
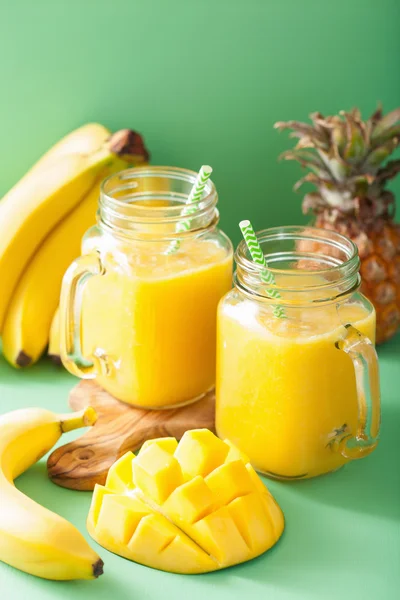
[{"xmin": 0, "ymin": 130, "xmax": 148, "ymax": 332}]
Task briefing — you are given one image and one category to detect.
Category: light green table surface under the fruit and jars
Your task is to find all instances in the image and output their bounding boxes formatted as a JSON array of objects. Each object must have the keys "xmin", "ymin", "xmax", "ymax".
[{"xmin": 0, "ymin": 336, "xmax": 400, "ymax": 600}]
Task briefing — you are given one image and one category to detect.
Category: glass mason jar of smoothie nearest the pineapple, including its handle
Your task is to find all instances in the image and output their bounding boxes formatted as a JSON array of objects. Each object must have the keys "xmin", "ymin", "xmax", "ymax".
[{"xmin": 216, "ymin": 227, "xmax": 380, "ymax": 479}]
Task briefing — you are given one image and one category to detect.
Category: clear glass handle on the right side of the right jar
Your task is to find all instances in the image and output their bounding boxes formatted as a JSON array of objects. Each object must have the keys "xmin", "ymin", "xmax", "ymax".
[{"xmin": 333, "ymin": 324, "xmax": 380, "ymax": 459}]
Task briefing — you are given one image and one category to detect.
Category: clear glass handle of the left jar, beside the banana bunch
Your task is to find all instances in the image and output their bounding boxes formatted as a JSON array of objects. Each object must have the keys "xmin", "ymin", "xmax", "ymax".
[{"xmin": 60, "ymin": 252, "xmax": 110, "ymax": 379}]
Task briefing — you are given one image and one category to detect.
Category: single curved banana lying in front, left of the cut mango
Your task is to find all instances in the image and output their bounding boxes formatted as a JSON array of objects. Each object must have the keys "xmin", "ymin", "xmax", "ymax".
[{"xmin": 0, "ymin": 407, "xmax": 103, "ymax": 580}]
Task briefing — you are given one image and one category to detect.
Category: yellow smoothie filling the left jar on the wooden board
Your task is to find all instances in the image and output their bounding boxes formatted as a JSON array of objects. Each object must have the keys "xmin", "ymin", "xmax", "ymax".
[{"xmin": 82, "ymin": 239, "xmax": 232, "ymax": 408}]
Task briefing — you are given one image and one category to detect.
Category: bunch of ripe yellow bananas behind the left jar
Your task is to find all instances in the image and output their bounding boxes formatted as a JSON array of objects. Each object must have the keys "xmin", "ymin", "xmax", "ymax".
[{"xmin": 0, "ymin": 123, "xmax": 149, "ymax": 368}]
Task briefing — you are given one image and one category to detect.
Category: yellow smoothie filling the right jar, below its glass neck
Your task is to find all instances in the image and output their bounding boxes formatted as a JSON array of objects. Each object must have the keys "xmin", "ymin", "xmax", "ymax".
[{"xmin": 216, "ymin": 292, "xmax": 375, "ymax": 478}]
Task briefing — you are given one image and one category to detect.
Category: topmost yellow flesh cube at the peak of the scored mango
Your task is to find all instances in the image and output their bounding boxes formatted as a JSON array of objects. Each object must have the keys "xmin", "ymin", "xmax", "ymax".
[{"xmin": 175, "ymin": 429, "xmax": 229, "ymax": 479}]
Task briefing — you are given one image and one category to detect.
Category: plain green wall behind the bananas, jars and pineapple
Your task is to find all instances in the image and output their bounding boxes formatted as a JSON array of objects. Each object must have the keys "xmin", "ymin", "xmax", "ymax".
[{"xmin": 0, "ymin": 0, "xmax": 400, "ymax": 242}]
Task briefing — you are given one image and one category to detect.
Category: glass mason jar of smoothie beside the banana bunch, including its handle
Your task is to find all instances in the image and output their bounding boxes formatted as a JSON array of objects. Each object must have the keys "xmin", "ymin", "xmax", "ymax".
[{"xmin": 60, "ymin": 167, "xmax": 232, "ymax": 408}]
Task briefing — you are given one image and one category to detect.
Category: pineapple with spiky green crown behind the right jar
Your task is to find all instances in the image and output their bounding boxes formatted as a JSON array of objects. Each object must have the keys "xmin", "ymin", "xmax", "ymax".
[{"xmin": 275, "ymin": 107, "xmax": 400, "ymax": 343}]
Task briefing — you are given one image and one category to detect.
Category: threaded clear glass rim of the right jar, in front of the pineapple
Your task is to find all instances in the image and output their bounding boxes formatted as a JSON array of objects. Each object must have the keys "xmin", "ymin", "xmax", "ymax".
[{"xmin": 235, "ymin": 225, "xmax": 360, "ymax": 305}]
